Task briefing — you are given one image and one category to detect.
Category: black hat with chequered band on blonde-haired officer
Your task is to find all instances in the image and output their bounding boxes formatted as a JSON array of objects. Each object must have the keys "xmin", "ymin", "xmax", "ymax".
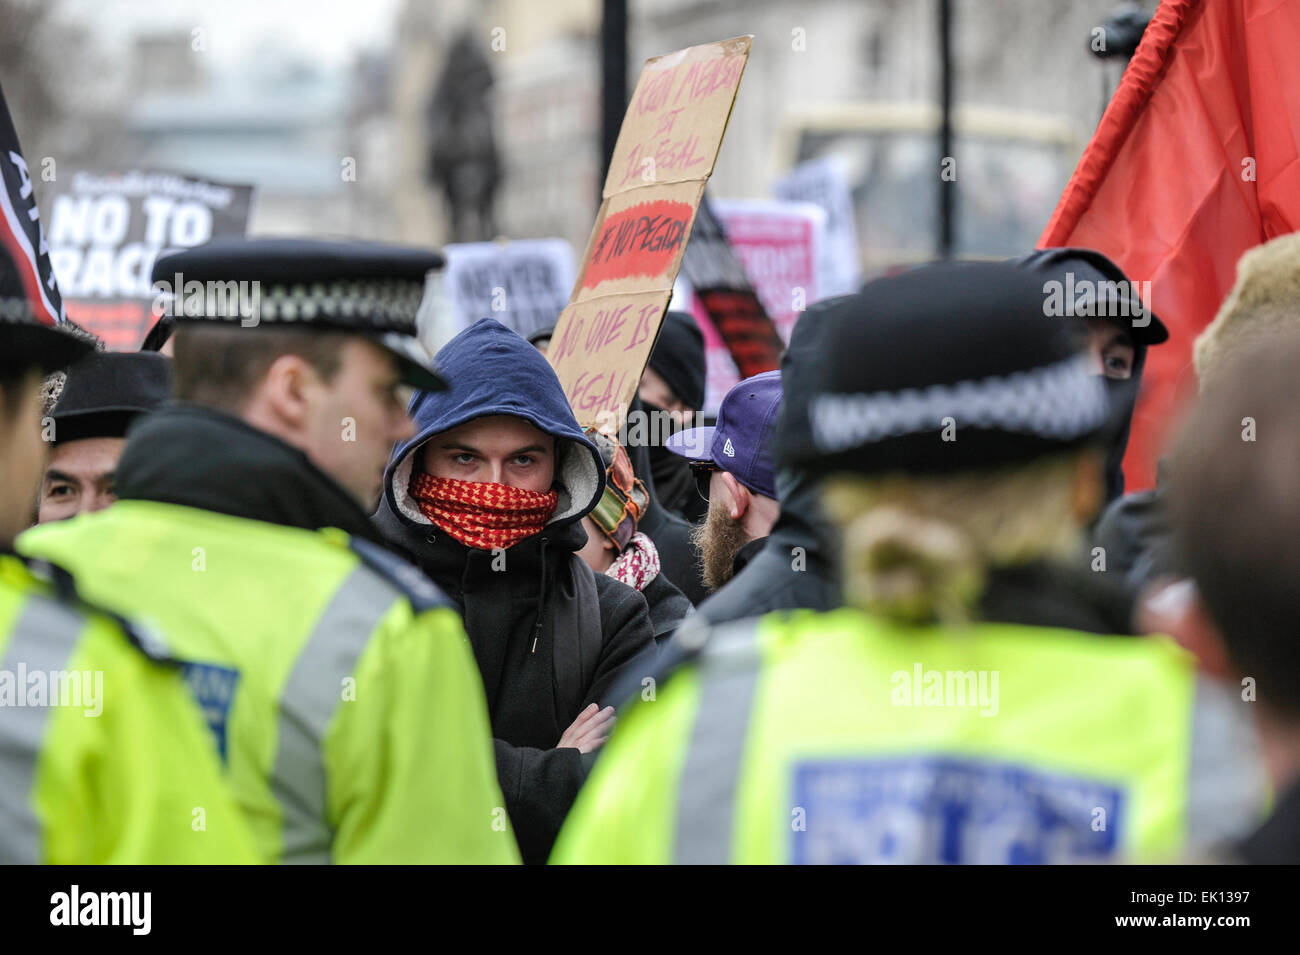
[{"xmin": 776, "ymin": 262, "xmax": 1108, "ymax": 474}]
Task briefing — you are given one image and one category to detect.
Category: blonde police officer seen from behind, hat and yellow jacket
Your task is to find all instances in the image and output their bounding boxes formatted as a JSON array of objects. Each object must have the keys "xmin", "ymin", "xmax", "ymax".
[{"xmin": 553, "ymin": 264, "xmax": 1261, "ymax": 863}]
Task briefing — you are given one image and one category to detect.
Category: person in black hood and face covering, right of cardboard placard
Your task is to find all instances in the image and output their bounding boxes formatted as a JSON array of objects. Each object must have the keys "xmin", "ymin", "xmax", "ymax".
[{"xmin": 637, "ymin": 312, "xmax": 706, "ymax": 524}]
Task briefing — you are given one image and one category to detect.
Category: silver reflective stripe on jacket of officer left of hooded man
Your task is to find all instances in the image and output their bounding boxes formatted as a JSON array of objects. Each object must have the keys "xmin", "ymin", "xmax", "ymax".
[{"xmin": 270, "ymin": 565, "xmax": 398, "ymax": 863}]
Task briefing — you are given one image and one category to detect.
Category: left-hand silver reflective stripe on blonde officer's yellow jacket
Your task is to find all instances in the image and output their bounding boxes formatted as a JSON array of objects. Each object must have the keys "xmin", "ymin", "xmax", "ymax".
[{"xmin": 673, "ymin": 621, "xmax": 761, "ymax": 865}]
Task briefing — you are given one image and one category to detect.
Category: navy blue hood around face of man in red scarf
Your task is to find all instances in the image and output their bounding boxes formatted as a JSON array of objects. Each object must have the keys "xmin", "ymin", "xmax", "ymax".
[{"xmin": 380, "ymin": 318, "xmax": 605, "ymax": 526}]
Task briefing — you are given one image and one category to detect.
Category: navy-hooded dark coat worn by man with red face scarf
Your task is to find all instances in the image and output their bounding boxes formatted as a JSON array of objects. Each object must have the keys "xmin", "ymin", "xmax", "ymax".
[{"xmin": 374, "ymin": 318, "xmax": 655, "ymax": 863}]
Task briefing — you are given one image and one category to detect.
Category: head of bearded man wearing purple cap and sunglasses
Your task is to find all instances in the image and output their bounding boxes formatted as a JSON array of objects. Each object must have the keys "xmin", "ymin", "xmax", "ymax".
[{"xmin": 667, "ymin": 372, "xmax": 781, "ymax": 591}]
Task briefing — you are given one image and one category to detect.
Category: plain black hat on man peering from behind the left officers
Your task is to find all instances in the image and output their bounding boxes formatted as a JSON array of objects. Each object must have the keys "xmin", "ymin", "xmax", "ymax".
[{"xmin": 49, "ymin": 352, "xmax": 172, "ymax": 444}]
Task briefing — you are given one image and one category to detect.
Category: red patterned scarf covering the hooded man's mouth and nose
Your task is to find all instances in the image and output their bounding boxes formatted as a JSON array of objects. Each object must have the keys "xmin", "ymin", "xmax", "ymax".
[{"xmin": 410, "ymin": 473, "xmax": 560, "ymax": 551}]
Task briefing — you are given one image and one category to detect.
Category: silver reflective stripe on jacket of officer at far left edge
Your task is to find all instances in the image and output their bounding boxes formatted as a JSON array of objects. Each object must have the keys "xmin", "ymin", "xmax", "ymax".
[{"xmin": 0, "ymin": 595, "xmax": 86, "ymax": 865}]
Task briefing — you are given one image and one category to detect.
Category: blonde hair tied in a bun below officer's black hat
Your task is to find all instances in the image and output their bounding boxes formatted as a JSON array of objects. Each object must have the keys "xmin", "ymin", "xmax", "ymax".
[{"xmin": 823, "ymin": 453, "xmax": 1080, "ymax": 624}]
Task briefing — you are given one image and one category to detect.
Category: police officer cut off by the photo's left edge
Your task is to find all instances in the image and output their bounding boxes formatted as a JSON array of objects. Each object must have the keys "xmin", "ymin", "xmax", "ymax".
[{"xmin": 0, "ymin": 243, "xmax": 256, "ymax": 864}]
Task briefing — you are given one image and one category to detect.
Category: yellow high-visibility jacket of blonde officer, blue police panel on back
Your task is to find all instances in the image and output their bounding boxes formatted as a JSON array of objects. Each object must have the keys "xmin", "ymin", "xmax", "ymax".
[{"xmin": 551, "ymin": 609, "xmax": 1258, "ymax": 863}]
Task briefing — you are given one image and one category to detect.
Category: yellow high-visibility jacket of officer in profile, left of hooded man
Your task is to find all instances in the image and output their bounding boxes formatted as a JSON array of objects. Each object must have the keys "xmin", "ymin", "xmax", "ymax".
[{"xmin": 18, "ymin": 500, "xmax": 519, "ymax": 863}]
